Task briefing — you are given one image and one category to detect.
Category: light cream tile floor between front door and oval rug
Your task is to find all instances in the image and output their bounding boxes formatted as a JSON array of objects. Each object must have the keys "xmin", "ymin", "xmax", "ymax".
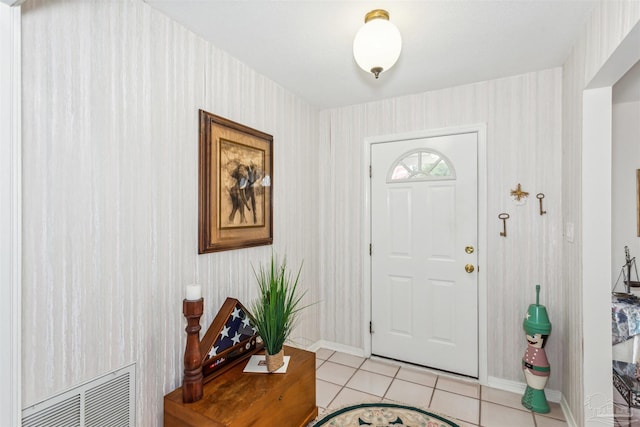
[{"xmin": 316, "ymin": 349, "xmax": 567, "ymax": 427}]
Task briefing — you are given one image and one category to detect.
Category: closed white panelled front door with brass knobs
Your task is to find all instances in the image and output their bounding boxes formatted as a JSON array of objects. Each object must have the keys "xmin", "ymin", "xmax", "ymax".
[{"xmin": 371, "ymin": 132, "xmax": 478, "ymax": 377}]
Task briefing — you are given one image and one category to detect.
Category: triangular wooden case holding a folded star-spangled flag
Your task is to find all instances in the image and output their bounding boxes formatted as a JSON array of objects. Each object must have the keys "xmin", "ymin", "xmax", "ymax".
[{"xmin": 200, "ymin": 298, "xmax": 263, "ymax": 383}]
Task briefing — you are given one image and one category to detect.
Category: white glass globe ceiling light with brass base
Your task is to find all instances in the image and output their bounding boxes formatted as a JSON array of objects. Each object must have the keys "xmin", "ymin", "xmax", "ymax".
[{"xmin": 353, "ymin": 9, "xmax": 402, "ymax": 79}]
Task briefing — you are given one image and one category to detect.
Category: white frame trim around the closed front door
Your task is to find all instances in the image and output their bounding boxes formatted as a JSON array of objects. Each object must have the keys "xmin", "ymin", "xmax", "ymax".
[{"xmin": 362, "ymin": 123, "xmax": 488, "ymax": 385}]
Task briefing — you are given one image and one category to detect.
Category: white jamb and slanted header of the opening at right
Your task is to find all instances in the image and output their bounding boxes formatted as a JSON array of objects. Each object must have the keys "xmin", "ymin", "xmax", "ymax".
[{"xmin": 580, "ymin": 21, "xmax": 640, "ymax": 427}]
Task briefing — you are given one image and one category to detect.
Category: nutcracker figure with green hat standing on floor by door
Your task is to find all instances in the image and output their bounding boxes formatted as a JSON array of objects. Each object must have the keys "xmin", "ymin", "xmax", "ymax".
[{"xmin": 522, "ymin": 285, "xmax": 551, "ymax": 414}]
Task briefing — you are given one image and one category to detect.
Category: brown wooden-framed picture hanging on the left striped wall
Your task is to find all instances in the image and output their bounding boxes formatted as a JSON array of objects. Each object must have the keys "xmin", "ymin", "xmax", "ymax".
[{"xmin": 198, "ymin": 110, "xmax": 273, "ymax": 254}]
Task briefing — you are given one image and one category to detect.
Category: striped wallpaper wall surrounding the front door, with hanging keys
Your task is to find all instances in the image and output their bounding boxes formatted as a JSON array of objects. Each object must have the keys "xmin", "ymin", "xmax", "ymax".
[{"xmin": 320, "ymin": 68, "xmax": 564, "ymax": 390}]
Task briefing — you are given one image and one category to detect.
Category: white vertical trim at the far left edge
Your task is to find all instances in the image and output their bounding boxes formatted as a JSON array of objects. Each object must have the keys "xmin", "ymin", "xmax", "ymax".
[{"xmin": 0, "ymin": 2, "xmax": 22, "ymax": 426}]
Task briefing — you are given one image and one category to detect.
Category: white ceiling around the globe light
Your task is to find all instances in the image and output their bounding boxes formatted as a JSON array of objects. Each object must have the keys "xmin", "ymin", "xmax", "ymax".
[{"xmin": 145, "ymin": 0, "xmax": 597, "ymax": 108}]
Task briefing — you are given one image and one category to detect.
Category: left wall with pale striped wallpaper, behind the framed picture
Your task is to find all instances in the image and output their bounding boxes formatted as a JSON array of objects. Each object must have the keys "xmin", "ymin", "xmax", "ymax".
[{"xmin": 22, "ymin": 0, "xmax": 320, "ymax": 426}]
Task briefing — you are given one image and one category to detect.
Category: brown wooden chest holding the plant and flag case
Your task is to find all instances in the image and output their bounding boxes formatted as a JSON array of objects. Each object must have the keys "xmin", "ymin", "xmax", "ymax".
[{"xmin": 164, "ymin": 346, "xmax": 318, "ymax": 427}]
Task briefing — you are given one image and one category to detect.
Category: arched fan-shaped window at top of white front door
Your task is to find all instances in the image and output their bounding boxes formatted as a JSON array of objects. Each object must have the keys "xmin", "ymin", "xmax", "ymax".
[{"xmin": 387, "ymin": 149, "xmax": 456, "ymax": 183}]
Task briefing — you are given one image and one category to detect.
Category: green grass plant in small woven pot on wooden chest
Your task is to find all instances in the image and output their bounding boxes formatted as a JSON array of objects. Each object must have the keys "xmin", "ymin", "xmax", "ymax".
[{"xmin": 247, "ymin": 254, "xmax": 305, "ymax": 372}]
